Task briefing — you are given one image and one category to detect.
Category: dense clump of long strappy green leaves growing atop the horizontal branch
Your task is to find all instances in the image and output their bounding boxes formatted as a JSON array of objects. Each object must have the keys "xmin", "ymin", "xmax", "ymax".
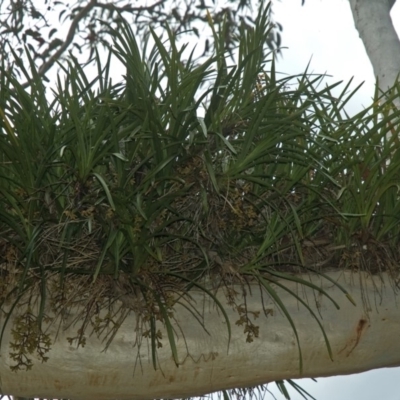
[{"xmin": 0, "ymin": 3, "xmax": 400, "ymax": 396}]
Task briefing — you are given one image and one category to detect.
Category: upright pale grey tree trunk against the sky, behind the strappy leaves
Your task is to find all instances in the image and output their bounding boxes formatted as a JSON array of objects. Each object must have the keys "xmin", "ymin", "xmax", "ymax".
[{"xmin": 348, "ymin": 0, "xmax": 400, "ymax": 94}]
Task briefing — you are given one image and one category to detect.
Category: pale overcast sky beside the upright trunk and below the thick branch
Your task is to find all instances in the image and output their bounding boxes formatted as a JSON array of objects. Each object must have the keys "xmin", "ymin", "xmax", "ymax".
[{"xmin": 266, "ymin": 0, "xmax": 400, "ymax": 400}]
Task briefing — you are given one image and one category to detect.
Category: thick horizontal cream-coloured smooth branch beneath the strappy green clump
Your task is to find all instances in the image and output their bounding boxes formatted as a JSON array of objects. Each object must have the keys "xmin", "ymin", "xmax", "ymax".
[{"xmin": 0, "ymin": 272, "xmax": 400, "ymax": 400}]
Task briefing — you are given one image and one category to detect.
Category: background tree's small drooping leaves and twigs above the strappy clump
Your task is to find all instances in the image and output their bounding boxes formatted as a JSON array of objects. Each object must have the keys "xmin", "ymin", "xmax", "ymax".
[{"xmin": 0, "ymin": 0, "xmax": 282, "ymax": 83}]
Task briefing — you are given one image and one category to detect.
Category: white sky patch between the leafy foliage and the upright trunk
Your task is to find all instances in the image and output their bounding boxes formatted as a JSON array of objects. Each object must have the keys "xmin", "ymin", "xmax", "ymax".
[{"xmin": 273, "ymin": 0, "xmax": 374, "ymax": 112}]
